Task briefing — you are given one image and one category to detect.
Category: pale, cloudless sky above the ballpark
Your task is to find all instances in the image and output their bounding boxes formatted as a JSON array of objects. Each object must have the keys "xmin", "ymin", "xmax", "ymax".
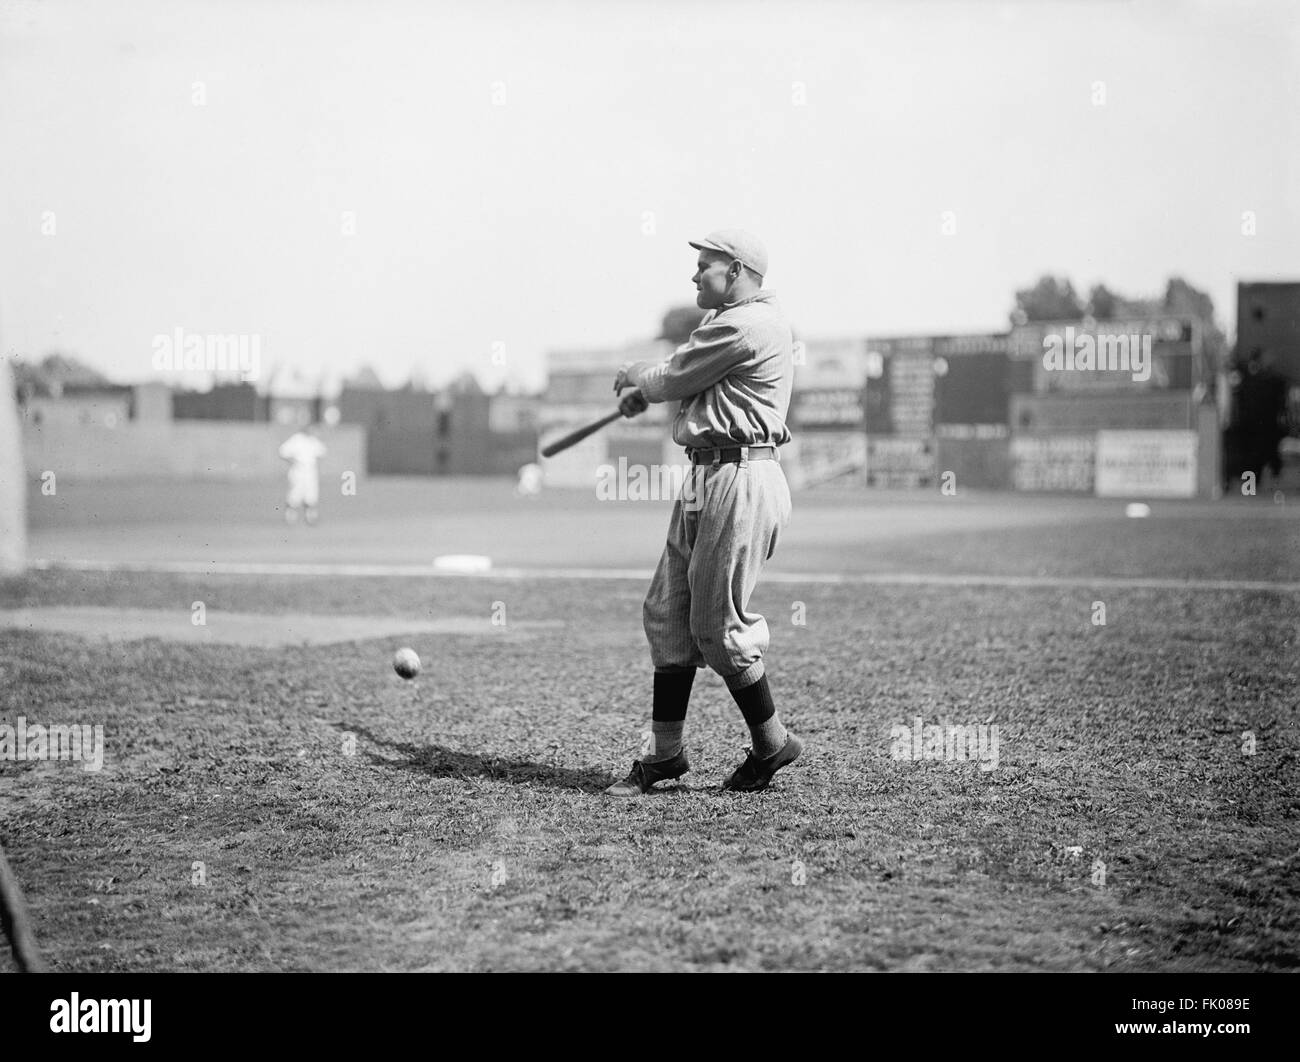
[{"xmin": 0, "ymin": 0, "xmax": 1300, "ymax": 389}]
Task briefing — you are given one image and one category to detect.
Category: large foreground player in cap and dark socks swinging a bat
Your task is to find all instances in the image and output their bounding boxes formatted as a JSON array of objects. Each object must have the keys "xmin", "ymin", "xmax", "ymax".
[{"xmin": 606, "ymin": 229, "xmax": 803, "ymax": 797}]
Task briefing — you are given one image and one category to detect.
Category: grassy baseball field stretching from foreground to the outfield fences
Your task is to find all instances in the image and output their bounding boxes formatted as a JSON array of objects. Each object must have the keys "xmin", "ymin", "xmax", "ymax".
[{"xmin": 0, "ymin": 481, "xmax": 1300, "ymax": 971}]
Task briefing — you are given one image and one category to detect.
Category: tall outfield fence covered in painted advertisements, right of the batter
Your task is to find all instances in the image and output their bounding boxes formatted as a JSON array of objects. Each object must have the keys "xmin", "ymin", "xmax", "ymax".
[{"xmin": 790, "ymin": 315, "xmax": 1219, "ymax": 497}]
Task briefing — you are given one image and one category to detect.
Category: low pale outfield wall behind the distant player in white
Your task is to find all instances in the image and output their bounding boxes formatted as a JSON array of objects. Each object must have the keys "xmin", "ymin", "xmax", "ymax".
[{"xmin": 22, "ymin": 421, "xmax": 365, "ymax": 480}]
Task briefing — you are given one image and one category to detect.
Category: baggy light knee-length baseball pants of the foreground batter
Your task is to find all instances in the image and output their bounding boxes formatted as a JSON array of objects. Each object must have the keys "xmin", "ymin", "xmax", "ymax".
[{"xmin": 642, "ymin": 460, "xmax": 790, "ymax": 689}]
